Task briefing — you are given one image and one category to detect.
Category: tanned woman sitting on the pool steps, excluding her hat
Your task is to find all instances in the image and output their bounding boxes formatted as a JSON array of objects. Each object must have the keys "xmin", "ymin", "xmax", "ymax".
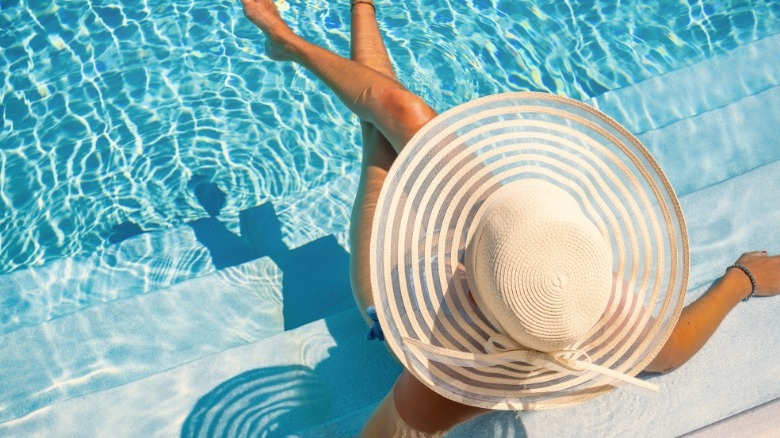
[{"xmin": 243, "ymin": 0, "xmax": 780, "ymax": 436}]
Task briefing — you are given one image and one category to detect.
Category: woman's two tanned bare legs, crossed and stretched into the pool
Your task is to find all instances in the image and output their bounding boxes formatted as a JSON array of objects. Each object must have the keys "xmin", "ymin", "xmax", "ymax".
[{"xmin": 243, "ymin": 0, "xmax": 436, "ymax": 322}]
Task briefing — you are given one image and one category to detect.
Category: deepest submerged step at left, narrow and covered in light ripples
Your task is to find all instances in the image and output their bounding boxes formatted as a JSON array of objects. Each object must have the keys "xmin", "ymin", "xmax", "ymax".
[{"xmin": 0, "ymin": 226, "xmax": 214, "ymax": 334}]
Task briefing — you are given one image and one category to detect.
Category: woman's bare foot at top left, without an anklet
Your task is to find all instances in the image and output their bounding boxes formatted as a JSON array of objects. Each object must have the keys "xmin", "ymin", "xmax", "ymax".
[{"xmin": 241, "ymin": 0, "xmax": 298, "ymax": 61}]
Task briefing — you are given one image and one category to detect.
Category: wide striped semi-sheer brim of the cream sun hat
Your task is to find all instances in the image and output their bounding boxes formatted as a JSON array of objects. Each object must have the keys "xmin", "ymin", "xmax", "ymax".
[{"xmin": 370, "ymin": 92, "xmax": 689, "ymax": 410}]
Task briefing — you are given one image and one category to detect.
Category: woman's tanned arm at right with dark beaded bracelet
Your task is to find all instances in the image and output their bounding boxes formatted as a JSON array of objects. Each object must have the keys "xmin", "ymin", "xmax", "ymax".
[{"xmin": 645, "ymin": 251, "xmax": 780, "ymax": 373}]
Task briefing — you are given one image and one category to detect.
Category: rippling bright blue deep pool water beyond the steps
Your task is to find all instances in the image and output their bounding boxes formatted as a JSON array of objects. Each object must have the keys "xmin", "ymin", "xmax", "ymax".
[{"xmin": 0, "ymin": 0, "xmax": 780, "ymax": 273}]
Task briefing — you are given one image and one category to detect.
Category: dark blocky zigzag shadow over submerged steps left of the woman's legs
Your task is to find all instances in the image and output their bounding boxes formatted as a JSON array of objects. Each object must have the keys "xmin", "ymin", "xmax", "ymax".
[{"xmin": 110, "ymin": 175, "xmax": 355, "ymax": 330}]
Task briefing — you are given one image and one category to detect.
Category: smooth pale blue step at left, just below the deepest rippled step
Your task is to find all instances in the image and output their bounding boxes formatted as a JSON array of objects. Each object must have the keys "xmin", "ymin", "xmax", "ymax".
[{"xmin": 0, "ymin": 258, "xmax": 283, "ymax": 424}]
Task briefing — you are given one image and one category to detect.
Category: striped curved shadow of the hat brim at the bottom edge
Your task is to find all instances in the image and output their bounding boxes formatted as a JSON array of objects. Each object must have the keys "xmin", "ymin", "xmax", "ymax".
[{"xmin": 181, "ymin": 365, "xmax": 329, "ymax": 438}]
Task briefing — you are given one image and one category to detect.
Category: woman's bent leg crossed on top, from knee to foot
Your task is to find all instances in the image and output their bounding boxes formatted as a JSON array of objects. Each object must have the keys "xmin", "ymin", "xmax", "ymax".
[{"xmin": 242, "ymin": 0, "xmax": 436, "ymax": 151}]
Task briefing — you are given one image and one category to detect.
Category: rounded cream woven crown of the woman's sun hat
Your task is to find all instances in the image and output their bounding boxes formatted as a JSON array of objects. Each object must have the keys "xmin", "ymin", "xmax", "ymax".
[{"xmin": 466, "ymin": 180, "xmax": 612, "ymax": 352}]
